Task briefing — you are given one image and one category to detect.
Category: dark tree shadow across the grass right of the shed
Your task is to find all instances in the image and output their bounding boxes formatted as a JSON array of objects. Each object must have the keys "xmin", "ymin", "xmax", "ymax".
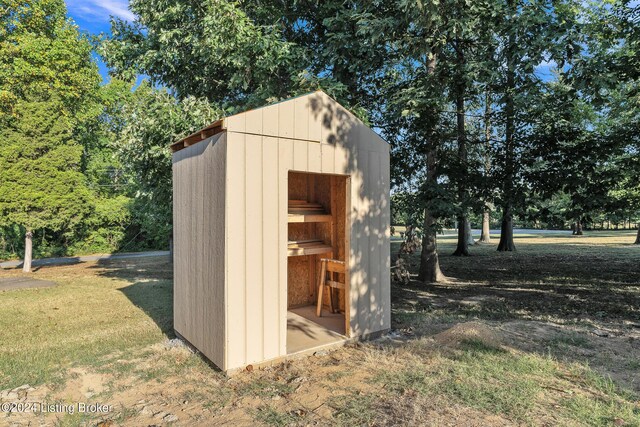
[{"xmin": 392, "ymin": 245, "xmax": 640, "ymax": 328}]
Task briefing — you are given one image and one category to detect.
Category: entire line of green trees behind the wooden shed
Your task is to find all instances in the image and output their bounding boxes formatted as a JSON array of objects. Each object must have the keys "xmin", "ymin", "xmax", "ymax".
[{"xmin": 0, "ymin": 0, "xmax": 640, "ymax": 281}]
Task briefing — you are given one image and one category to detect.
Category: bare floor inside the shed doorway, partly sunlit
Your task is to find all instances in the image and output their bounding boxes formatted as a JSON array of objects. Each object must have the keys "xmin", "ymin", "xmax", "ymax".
[{"xmin": 287, "ymin": 305, "xmax": 347, "ymax": 354}]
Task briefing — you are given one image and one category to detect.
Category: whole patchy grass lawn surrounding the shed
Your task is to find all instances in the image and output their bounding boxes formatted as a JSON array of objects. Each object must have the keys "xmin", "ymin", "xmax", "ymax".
[{"xmin": 0, "ymin": 232, "xmax": 640, "ymax": 426}]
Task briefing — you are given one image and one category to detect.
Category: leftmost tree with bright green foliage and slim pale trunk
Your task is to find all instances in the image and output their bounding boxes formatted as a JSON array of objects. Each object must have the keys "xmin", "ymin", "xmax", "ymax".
[{"xmin": 0, "ymin": 0, "xmax": 100, "ymax": 271}]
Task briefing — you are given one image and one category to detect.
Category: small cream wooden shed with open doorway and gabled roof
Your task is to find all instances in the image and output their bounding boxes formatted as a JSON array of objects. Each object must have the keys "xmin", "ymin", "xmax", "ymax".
[{"xmin": 171, "ymin": 91, "xmax": 391, "ymax": 371}]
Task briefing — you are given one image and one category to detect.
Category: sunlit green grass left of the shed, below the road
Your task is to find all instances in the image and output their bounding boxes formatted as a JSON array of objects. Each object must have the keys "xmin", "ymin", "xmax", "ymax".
[{"xmin": 0, "ymin": 261, "xmax": 172, "ymax": 389}]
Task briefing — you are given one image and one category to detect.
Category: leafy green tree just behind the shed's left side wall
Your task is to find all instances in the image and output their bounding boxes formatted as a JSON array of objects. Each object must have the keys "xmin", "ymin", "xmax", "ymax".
[{"xmin": 113, "ymin": 82, "xmax": 223, "ymax": 247}]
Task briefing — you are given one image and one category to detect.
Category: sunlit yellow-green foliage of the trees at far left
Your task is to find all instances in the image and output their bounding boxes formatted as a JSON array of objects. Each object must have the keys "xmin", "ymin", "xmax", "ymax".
[{"xmin": 0, "ymin": 0, "xmax": 148, "ymax": 258}]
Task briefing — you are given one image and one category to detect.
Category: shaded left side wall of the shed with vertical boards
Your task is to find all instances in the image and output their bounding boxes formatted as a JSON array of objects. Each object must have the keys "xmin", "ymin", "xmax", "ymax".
[{"xmin": 173, "ymin": 133, "xmax": 226, "ymax": 367}]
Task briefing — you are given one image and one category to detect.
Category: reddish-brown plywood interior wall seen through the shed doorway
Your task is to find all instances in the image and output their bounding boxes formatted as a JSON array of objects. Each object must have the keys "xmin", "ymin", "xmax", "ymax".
[{"xmin": 287, "ymin": 172, "xmax": 347, "ymax": 312}]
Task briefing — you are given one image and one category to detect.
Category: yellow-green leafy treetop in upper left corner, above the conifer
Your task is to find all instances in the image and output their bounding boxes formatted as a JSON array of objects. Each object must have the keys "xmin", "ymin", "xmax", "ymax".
[{"xmin": 0, "ymin": 0, "xmax": 100, "ymax": 117}]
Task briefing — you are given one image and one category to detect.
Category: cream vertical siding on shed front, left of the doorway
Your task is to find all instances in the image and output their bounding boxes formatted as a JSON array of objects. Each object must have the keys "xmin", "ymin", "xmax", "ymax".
[{"xmin": 226, "ymin": 132, "xmax": 292, "ymax": 369}]
